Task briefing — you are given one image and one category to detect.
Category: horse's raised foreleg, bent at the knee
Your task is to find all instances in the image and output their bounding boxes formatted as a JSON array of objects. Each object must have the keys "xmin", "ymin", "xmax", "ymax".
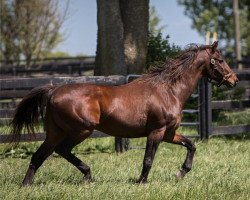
[{"xmin": 164, "ymin": 133, "xmax": 196, "ymax": 180}]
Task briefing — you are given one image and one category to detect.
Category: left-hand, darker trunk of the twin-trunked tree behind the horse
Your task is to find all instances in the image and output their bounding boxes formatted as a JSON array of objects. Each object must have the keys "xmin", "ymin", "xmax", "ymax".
[{"xmin": 95, "ymin": 0, "xmax": 127, "ymax": 75}]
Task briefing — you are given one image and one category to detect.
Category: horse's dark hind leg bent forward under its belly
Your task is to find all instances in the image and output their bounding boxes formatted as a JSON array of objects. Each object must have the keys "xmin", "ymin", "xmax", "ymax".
[{"xmin": 55, "ymin": 131, "xmax": 92, "ymax": 182}]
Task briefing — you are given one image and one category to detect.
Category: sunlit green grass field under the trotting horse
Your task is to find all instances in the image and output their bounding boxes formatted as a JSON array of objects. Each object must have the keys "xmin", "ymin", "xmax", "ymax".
[{"xmin": 0, "ymin": 135, "xmax": 250, "ymax": 200}]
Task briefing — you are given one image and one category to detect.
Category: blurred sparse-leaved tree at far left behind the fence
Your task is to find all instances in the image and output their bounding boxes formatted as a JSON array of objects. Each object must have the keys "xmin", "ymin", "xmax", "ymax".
[{"xmin": 0, "ymin": 0, "xmax": 68, "ymax": 68}]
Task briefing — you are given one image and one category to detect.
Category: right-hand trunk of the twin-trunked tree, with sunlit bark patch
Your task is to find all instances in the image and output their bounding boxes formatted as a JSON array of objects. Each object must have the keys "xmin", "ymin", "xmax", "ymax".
[{"xmin": 120, "ymin": 0, "xmax": 149, "ymax": 74}]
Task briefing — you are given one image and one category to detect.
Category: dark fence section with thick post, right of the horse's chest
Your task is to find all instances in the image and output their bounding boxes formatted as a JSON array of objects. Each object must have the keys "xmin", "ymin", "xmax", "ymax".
[{"xmin": 200, "ymin": 70, "xmax": 250, "ymax": 139}]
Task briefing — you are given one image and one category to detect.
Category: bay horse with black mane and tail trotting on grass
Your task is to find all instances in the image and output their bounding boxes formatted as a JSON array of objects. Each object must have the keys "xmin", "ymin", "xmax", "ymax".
[{"xmin": 12, "ymin": 42, "xmax": 238, "ymax": 186}]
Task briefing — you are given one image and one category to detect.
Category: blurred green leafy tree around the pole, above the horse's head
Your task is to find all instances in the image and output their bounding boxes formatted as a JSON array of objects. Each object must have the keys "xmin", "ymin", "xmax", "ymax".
[{"xmin": 178, "ymin": 0, "xmax": 250, "ymax": 55}]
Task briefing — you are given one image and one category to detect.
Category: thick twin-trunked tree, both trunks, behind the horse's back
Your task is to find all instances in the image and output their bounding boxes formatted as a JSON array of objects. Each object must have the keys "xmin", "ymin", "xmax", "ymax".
[{"xmin": 95, "ymin": 0, "xmax": 149, "ymax": 75}]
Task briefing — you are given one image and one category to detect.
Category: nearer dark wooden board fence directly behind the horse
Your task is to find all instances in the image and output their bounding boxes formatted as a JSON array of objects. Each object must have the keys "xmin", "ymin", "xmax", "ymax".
[{"xmin": 0, "ymin": 71, "xmax": 250, "ymax": 148}]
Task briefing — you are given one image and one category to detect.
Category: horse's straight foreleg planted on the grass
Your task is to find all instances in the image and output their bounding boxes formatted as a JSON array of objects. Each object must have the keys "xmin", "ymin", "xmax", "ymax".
[{"xmin": 137, "ymin": 136, "xmax": 161, "ymax": 183}]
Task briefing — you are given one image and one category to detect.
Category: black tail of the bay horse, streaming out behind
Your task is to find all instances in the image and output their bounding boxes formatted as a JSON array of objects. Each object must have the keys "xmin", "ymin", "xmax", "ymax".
[{"xmin": 11, "ymin": 85, "xmax": 56, "ymax": 144}]
